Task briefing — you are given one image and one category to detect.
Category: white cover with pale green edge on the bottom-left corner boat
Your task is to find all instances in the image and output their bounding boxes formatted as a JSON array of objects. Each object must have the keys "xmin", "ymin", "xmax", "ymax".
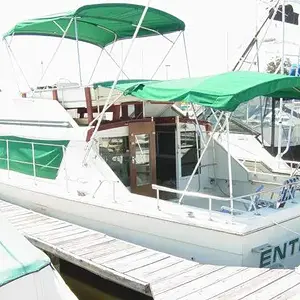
[{"xmin": 0, "ymin": 214, "xmax": 50, "ymax": 287}]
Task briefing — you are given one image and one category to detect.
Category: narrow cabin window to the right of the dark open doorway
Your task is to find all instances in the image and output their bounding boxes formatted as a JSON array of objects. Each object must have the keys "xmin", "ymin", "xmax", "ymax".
[{"xmin": 180, "ymin": 131, "xmax": 200, "ymax": 177}]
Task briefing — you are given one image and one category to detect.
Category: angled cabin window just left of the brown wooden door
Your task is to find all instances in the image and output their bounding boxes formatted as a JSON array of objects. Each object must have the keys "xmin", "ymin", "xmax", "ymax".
[{"xmin": 99, "ymin": 136, "xmax": 130, "ymax": 186}]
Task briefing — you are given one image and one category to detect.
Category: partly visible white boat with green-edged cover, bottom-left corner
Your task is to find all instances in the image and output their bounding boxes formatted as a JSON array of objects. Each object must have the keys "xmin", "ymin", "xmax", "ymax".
[{"xmin": 0, "ymin": 211, "xmax": 77, "ymax": 300}]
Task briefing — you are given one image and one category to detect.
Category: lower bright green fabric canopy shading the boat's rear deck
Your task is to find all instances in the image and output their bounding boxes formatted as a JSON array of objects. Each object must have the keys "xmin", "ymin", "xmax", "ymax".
[{"xmin": 95, "ymin": 71, "xmax": 300, "ymax": 111}]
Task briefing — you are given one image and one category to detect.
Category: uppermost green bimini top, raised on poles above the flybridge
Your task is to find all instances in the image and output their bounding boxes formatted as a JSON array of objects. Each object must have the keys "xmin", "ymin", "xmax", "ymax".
[{"xmin": 4, "ymin": 3, "xmax": 185, "ymax": 47}]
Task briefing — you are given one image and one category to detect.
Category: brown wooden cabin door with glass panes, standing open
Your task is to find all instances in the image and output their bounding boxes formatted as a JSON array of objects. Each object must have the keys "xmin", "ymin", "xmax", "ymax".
[{"xmin": 128, "ymin": 121, "xmax": 156, "ymax": 196}]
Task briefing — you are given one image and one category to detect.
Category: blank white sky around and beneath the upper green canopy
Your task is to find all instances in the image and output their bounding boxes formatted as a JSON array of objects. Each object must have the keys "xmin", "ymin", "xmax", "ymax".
[{"xmin": 0, "ymin": 0, "xmax": 298, "ymax": 94}]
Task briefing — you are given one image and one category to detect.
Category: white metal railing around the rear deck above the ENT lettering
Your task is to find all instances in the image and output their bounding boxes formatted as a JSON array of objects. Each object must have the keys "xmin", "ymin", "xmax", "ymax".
[{"xmin": 152, "ymin": 181, "xmax": 300, "ymax": 220}]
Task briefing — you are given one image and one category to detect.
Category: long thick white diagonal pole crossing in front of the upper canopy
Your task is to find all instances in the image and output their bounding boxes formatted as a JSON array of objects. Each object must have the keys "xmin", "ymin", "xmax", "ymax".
[{"xmin": 83, "ymin": 0, "xmax": 151, "ymax": 165}]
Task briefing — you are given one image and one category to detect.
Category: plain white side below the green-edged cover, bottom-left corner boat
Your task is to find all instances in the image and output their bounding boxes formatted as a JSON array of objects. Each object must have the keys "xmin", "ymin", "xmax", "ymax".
[{"xmin": 0, "ymin": 265, "xmax": 78, "ymax": 300}]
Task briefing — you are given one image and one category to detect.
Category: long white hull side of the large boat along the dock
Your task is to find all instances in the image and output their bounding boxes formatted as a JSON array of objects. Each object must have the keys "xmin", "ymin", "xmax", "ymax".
[{"xmin": 0, "ymin": 179, "xmax": 300, "ymax": 267}]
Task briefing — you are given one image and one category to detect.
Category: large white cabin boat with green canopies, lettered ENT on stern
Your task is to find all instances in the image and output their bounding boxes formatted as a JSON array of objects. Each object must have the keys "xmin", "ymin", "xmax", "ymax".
[{"xmin": 0, "ymin": 4, "xmax": 300, "ymax": 267}]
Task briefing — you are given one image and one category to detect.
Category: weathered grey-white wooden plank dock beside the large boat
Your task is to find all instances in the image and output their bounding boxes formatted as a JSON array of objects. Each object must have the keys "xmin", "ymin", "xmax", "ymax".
[{"xmin": 0, "ymin": 200, "xmax": 300, "ymax": 300}]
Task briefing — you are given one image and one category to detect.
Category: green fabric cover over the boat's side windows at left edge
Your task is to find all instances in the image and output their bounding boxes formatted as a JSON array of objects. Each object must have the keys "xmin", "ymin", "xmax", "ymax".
[{"xmin": 0, "ymin": 136, "xmax": 69, "ymax": 179}]
